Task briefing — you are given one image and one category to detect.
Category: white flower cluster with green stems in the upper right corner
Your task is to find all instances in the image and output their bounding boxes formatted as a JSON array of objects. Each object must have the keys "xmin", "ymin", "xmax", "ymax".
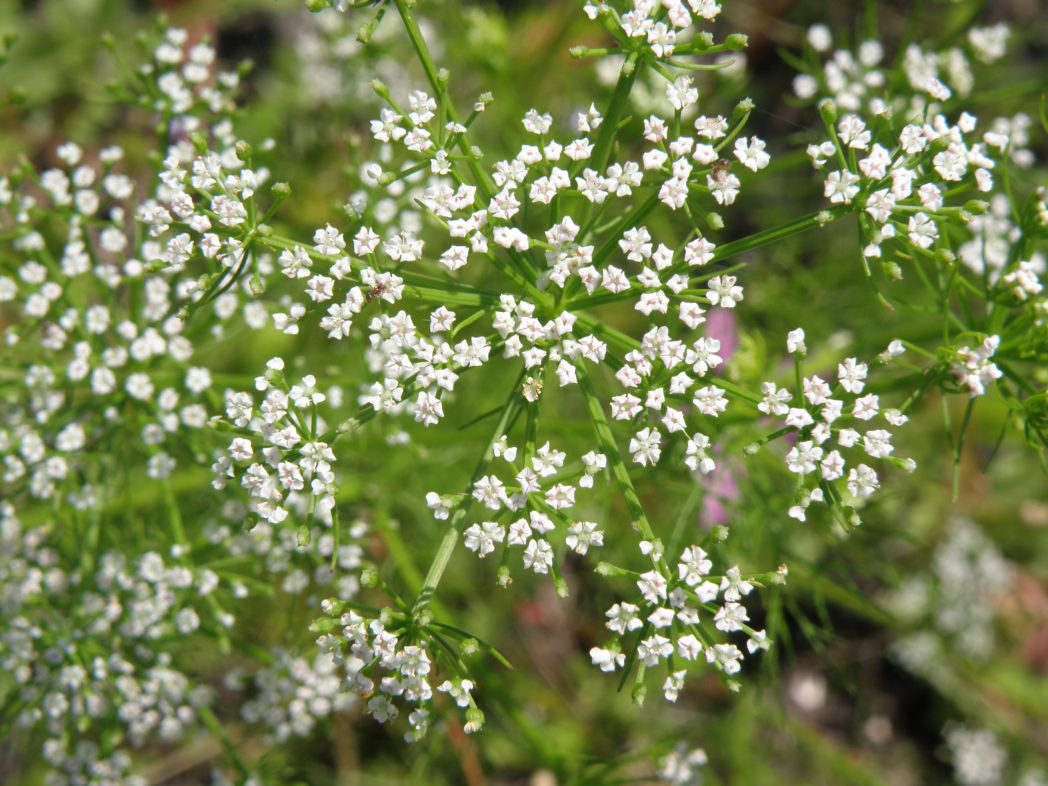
[{"xmin": 794, "ymin": 25, "xmax": 1044, "ymax": 282}]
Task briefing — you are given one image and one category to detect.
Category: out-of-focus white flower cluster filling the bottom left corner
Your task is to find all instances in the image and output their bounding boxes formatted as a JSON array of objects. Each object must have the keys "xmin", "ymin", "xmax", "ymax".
[{"xmin": 0, "ymin": 502, "xmax": 221, "ymax": 785}]
